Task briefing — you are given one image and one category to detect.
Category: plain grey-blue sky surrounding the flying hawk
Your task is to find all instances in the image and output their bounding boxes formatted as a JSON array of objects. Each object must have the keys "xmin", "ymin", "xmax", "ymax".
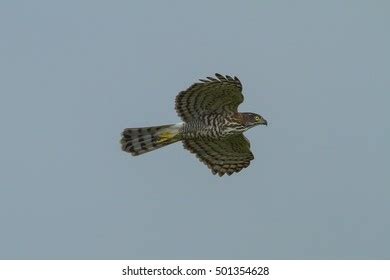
[{"xmin": 0, "ymin": 0, "xmax": 390, "ymax": 259}]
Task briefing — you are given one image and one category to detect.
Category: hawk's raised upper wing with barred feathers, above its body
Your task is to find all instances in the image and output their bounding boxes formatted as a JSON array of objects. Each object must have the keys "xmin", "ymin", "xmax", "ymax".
[{"xmin": 175, "ymin": 74, "xmax": 244, "ymax": 122}]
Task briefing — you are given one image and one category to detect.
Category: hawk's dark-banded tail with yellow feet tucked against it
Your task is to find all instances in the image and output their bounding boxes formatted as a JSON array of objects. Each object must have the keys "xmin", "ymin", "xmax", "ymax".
[{"xmin": 121, "ymin": 124, "xmax": 182, "ymax": 156}]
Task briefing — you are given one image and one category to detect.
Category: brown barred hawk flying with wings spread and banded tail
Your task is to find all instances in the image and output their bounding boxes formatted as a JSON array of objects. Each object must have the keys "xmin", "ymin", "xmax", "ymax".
[{"xmin": 121, "ymin": 74, "xmax": 267, "ymax": 176}]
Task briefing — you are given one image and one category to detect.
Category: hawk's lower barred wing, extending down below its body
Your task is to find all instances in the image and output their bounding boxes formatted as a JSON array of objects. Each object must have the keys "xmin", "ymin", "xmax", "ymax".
[{"xmin": 183, "ymin": 134, "xmax": 254, "ymax": 176}]
